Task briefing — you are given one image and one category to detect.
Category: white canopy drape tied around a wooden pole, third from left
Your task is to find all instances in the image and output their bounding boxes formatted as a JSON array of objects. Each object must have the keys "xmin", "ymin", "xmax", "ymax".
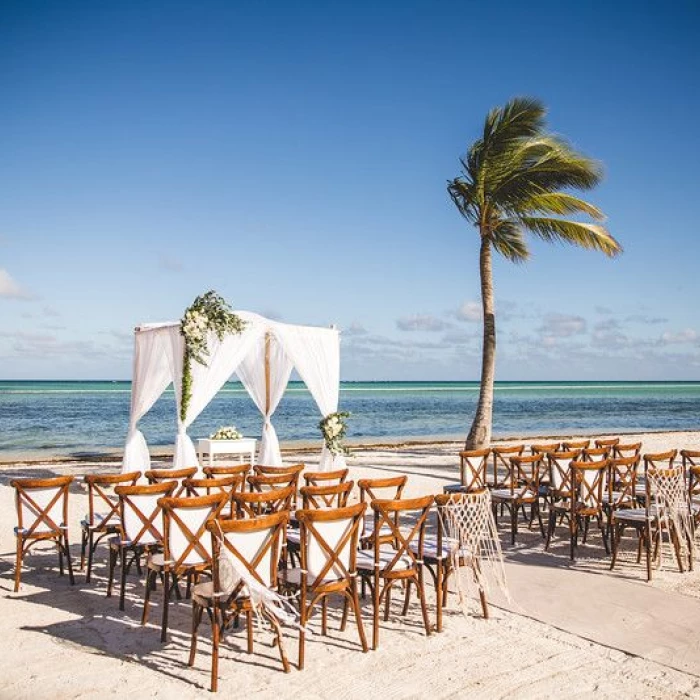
[{"xmin": 236, "ymin": 332, "xmax": 293, "ymax": 467}]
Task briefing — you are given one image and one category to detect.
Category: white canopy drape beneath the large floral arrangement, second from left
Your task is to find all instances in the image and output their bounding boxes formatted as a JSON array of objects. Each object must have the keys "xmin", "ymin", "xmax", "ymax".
[{"xmin": 164, "ymin": 323, "xmax": 265, "ymax": 469}]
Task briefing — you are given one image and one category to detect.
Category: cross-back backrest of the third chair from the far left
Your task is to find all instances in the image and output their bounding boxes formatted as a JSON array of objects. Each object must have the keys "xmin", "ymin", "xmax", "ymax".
[{"xmin": 114, "ymin": 481, "xmax": 178, "ymax": 546}]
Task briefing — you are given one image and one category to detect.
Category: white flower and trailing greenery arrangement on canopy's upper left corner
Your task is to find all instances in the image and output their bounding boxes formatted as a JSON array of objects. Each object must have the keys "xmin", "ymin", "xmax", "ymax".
[{"xmin": 180, "ymin": 290, "xmax": 246, "ymax": 421}]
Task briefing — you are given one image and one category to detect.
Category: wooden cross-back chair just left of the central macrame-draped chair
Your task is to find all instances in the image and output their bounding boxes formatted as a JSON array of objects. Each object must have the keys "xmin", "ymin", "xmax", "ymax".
[{"xmin": 357, "ymin": 496, "xmax": 440, "ymax": 649}]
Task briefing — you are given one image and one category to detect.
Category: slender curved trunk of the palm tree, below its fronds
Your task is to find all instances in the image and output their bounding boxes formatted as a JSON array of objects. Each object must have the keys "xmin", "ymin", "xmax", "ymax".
[{"xmin": 464, "ymin": 233, "xmax": 496, "ymax": 450}]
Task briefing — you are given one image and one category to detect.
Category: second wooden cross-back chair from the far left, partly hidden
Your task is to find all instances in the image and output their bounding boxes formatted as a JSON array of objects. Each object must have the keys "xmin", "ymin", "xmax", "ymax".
[{"xmin": 80, "ymin": 471, "xmax": 141, "ymax": 583}]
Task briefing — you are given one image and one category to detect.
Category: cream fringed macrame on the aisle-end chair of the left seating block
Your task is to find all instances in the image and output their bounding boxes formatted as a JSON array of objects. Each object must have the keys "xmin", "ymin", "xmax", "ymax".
[{"xmin": 438, "ymin": 490, "xmax": 511, "ymax": 614}]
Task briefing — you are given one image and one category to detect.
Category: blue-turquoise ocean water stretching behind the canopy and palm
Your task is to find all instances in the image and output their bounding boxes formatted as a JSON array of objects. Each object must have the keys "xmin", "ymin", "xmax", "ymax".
[{"xmin": 0, "ymin": 381, "xmax": 700, "ymax": 456}]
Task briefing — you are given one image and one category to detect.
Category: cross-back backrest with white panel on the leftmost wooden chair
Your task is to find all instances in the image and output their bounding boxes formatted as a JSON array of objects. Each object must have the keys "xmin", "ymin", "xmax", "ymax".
[{"xmin": 10, "ymin": 476, "xmax": 73, "ymax": 537}]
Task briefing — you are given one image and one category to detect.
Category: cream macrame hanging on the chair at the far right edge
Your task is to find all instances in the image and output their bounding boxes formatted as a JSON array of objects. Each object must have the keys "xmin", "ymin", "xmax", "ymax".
[{"xmin": 647, "ymin": 469, "xmax": 695, "ymax": 567}]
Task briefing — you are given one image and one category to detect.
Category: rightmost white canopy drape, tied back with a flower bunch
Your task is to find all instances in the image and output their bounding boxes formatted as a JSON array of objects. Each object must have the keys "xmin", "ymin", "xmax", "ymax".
[{"xmin": 273, "ymin": 323, "xmax": 345, "ymax": 471}]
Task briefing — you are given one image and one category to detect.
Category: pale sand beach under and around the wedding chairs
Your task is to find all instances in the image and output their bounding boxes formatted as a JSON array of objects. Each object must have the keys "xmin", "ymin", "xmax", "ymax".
[{"xmin": 0, "ymin": 433, "xmax": 700, "ymax": 699}]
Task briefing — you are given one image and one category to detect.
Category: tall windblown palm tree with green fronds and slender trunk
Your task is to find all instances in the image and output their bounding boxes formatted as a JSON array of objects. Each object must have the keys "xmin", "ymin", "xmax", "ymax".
[{"xmin": 447, "ymin": 98, "xmax": 622, "ymax": 449}]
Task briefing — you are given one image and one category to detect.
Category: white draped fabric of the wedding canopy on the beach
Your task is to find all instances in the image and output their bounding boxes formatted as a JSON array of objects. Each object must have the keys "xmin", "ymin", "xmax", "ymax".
[{"xmin": 122, "ymin": 311, "xmax": 344, "ymax": 472}]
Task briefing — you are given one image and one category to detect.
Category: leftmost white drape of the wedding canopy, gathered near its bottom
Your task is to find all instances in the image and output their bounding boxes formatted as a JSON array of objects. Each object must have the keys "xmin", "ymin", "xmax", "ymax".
[{"xmin": 122, "ymin": 330, "xmax": 173, "ymax": 473}]
